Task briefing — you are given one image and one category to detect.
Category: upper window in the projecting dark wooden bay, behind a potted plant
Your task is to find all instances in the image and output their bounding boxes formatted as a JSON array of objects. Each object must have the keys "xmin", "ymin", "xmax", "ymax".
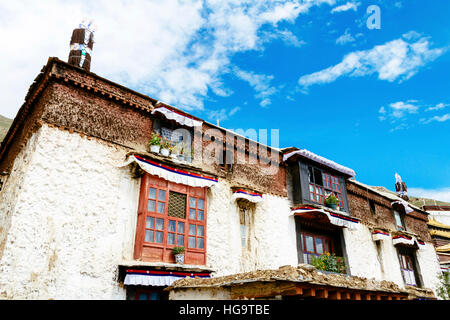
[{"xmin": 308, "ymin": 166, "xmax": 344, "ymax": 208}]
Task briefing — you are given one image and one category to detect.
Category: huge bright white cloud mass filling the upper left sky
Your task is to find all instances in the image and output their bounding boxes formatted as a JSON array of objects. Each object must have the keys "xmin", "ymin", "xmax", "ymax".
[{"xmin": 0, "ymin": 0, "xmax": 335, "ymax": 117}]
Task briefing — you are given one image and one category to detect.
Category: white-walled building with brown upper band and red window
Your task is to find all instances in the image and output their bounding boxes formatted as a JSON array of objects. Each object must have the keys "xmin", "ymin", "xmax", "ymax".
[{"xmin": 0, "ymin": 58, "xmax": 439, "ymax": 299}]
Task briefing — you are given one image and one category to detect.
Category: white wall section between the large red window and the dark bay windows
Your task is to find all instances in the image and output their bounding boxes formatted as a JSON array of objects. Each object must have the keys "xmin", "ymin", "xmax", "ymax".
[{"xmin": 207, "ymin": 179, "xmax": 297, "ymax": 275}]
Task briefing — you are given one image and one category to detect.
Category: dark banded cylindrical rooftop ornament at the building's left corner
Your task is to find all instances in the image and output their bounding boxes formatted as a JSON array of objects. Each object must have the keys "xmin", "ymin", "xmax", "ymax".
[{"xmin": 68, "ymin": 20, "xmax": 95, "ymax": 71}]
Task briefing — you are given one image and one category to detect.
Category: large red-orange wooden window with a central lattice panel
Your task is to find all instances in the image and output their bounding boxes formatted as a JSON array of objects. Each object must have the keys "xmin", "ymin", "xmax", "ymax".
[{"xmin": 134, "ymin": 174, "xmax": 206, "ymax": 265}]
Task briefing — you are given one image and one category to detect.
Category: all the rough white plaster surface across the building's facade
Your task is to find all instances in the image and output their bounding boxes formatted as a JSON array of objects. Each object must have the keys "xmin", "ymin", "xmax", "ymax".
[{"xmin": 0, "ymin": 125, "xmax": 439, "ymax": 299}]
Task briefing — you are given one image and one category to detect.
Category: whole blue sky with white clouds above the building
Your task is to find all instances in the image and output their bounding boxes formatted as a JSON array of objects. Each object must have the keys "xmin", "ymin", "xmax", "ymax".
[{"xmin": 0, "ymin": 0, "xmax": 450, "ymax": 201}]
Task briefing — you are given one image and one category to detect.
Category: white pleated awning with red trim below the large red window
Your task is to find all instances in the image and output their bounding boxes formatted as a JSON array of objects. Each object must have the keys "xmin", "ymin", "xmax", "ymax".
[{"xmin": 123, "ymin": 269, "xmax": 210, "ymax": 286}]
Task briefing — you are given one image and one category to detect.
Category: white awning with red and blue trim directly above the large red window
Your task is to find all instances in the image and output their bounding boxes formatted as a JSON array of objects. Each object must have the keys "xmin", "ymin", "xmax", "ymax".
[{"xmin": 121, "ymin": 155, "xmax": 218, "ymax": 187}]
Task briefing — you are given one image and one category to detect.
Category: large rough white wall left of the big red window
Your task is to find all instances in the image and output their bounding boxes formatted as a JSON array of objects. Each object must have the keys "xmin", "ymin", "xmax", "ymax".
[{"xmin": 0, "ymin": 125, "xmax": 139, "ymax": 299}]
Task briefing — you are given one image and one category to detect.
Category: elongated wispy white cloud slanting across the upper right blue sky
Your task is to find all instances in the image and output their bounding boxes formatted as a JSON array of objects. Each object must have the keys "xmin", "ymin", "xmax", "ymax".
[{"xmin": 298, "ymin": 32, "xmax": 445, "ymax": 87}]
